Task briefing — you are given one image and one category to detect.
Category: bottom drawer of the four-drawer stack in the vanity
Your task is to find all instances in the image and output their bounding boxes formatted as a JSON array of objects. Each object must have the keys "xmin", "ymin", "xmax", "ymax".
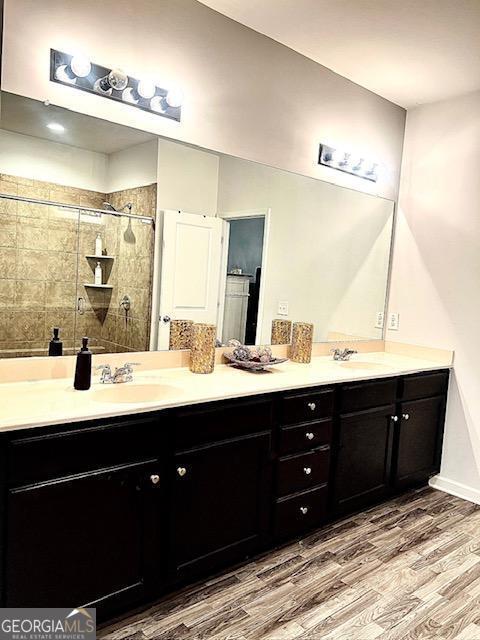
[{"xmin": 273, "ymin": 486, "xmax": 327, "ymax": 539}]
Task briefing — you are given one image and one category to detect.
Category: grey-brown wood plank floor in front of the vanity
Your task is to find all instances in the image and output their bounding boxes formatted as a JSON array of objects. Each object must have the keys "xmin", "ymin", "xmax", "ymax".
[{"xmin": 98, "ymin": 488, "xmax": 480, "ymax": 640}]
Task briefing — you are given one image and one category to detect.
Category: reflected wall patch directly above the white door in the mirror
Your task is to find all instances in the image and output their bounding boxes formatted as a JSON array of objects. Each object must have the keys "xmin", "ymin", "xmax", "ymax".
[{"xmin": 157, "ymin": 140, "xmax": 219, "ymax": 216}]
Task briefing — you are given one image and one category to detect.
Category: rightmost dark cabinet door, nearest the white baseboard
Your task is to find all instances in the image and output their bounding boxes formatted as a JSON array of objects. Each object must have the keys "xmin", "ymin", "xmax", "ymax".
[{"xmin": 395, "ymin": 396, "xmax": 445, "ymax": 487}]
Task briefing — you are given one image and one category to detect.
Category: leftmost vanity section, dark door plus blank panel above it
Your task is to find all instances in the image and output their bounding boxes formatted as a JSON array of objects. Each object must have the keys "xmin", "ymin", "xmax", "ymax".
[{"xmin": 2, "ymin": 419, "xmax": 166, "ymax": 615}]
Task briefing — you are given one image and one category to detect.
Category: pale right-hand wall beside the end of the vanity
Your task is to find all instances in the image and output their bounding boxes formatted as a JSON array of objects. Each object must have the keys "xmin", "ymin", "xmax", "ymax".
[{"xmin": 387, "ymin": 92, "xmax": 480, "ymax": 502}]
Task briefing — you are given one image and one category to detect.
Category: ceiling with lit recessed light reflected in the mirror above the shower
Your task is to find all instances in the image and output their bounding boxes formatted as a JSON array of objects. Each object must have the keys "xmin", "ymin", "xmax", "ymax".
[{"xmin": 0, "ymin": 91, "xmax": 155, "ymax": 155}]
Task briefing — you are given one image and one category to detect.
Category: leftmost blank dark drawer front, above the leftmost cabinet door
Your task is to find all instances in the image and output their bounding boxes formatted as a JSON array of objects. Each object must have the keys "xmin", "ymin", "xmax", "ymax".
[{"xmin": 8, "ymin": 418, "xmax": 161, "ymax": 486}]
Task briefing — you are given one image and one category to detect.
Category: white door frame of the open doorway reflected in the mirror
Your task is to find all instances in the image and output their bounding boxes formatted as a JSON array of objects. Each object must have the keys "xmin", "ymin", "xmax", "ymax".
[{"xmin": 217, "ymin": 207, "xmax": 272, "ymax": 344}]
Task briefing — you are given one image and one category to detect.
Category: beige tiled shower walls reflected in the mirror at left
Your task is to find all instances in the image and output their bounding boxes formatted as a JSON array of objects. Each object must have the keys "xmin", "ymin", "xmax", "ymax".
[{"xmin": 0, "ymin": 174, "xmax": 156, "ymax": 357}]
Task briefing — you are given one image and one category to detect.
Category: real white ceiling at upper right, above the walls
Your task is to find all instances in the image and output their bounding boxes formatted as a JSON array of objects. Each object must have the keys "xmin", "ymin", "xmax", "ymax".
[{"xmin": 201, "ymin": 0, "xmax": 480, "ymax": 108}]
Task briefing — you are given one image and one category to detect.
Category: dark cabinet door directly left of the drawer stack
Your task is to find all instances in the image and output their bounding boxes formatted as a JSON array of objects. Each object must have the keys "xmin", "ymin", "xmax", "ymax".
[{"xmin": 170, "ymin": 433, "xmax": 271, "ymax": 580}]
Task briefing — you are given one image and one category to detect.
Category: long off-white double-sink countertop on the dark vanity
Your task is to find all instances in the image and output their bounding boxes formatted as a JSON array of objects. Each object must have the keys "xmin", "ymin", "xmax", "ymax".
[{"xmin": 0, "ymin": 351, "xmax": 446, "ymax": 431}]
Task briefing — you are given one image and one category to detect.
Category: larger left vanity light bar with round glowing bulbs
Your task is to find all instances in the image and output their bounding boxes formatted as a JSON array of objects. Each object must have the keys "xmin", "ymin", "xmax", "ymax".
[{"xmin": 50, "ymin": 49, "xmax": 183, "ymax": 122}]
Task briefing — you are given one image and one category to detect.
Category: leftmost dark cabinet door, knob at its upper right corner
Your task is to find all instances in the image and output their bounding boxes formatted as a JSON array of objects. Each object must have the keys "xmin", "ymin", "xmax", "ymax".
[{"xmin": 6, "ymin": 462, "xmax": 160, "ymax": 615}]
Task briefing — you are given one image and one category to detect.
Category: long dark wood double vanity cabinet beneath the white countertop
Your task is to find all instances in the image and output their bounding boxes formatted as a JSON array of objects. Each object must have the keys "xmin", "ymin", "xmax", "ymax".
[{"xmin": 0, "ymin": 368, "xmax": 449, "ymax": 619}]
